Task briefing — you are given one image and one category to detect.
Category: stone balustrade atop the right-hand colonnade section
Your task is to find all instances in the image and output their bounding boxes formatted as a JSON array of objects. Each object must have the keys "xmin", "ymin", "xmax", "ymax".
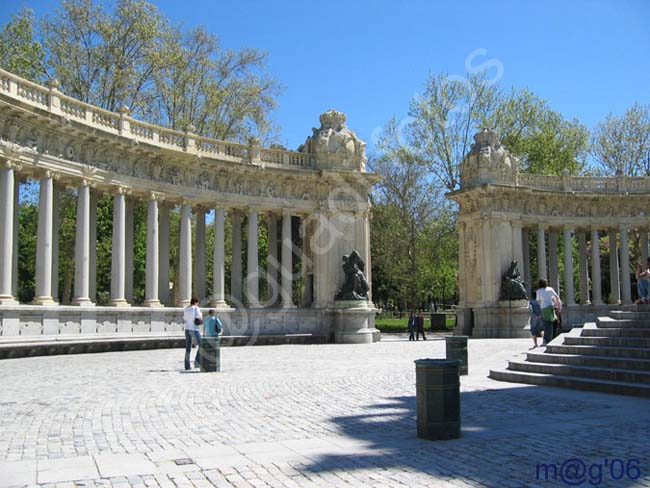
[{"xmin": 517, "ymin": 173, "xmax": 650, "ymax": 193}]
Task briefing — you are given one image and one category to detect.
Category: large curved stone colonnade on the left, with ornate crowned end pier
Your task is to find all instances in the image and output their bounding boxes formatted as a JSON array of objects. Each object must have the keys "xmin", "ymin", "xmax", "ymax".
[{"xmin": 0, "ymin": 70, "xmax": 378, "ymax": 342}]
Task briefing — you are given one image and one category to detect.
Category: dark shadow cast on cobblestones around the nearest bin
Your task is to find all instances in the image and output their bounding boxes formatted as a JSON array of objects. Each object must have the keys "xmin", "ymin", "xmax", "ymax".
[{"xmin": 306, "ymin": 387, "xmax": 650, "ymax": 487}]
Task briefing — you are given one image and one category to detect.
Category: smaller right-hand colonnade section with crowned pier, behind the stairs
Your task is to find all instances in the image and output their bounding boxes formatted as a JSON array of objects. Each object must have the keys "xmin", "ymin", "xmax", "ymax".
[{"xmin": 448, "ymin": 130, "xmax": 650, "ymax": 337}]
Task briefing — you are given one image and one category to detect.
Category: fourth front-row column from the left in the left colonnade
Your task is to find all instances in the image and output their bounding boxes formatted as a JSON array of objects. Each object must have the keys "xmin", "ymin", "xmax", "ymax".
[{"xmin": 111, "ymin": 187, "xmax": 129, "ymax": 307}]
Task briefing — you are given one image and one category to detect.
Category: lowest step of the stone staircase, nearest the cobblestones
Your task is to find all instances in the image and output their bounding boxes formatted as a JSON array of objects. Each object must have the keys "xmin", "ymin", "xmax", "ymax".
[{"xmin": 489, "ymin": 370, "xmax": 650, "ymax": 397}]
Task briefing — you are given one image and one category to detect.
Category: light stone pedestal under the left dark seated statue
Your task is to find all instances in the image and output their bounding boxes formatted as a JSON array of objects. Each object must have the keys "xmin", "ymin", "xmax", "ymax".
[{"xmin": 332, "ymin": 300, "xmax": 380, "ymax": 344}]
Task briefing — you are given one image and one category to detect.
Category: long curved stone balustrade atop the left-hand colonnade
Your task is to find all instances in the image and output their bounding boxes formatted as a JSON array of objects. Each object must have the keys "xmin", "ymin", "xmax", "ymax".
[{"xmin": 0, "ymin": 69, "xmax": 314, "ymax": 170}]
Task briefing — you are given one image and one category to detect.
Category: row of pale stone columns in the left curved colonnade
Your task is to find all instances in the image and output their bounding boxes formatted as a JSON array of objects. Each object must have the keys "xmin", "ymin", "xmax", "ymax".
[{"xmin": 0, "ymin": 164, "xmax": 312, "ymax": 308}]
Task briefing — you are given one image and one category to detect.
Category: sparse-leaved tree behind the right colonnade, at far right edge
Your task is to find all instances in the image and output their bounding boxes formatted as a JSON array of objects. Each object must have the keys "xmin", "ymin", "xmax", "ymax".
[{"xmin": 591, "ymin": 103, "xmax": 650, "ymax": 176}]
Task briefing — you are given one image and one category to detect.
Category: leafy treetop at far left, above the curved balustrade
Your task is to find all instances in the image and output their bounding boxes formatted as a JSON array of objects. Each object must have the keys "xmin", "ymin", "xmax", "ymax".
[{"xmin": 0, "ymin": 9, "xmax": 45, "ymax": 82}]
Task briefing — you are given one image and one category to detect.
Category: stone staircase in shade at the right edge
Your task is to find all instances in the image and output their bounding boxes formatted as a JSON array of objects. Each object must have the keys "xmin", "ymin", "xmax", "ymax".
[{"xmin": 489, "ymin": 311, "xmax": 650, "ymax": 397}]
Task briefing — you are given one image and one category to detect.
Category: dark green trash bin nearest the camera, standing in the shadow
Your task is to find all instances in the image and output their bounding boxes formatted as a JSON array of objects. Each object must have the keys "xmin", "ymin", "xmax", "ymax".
[{"xmin": 415, "ymin": 359, "xmax": 460, "ymax": 441}]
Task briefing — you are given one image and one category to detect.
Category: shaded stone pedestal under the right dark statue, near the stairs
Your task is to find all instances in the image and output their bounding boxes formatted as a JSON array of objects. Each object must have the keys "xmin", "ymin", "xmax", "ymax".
[{"xmin": 472, "ymin": 300, "xmax": 530, "ymax": 338}]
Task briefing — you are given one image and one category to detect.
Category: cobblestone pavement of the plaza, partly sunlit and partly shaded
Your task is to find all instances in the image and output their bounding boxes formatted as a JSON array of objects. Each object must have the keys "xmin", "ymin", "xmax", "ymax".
[{"xmin": 0, "ymin": 337, "xmax": 650, "ymax": 487}]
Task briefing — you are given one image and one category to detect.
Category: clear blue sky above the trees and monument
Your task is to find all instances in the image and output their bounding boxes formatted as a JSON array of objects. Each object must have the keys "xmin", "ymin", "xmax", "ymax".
[{"xmin": 0, "ymin": 0, "xmax": 650, "ymax": 148}]
